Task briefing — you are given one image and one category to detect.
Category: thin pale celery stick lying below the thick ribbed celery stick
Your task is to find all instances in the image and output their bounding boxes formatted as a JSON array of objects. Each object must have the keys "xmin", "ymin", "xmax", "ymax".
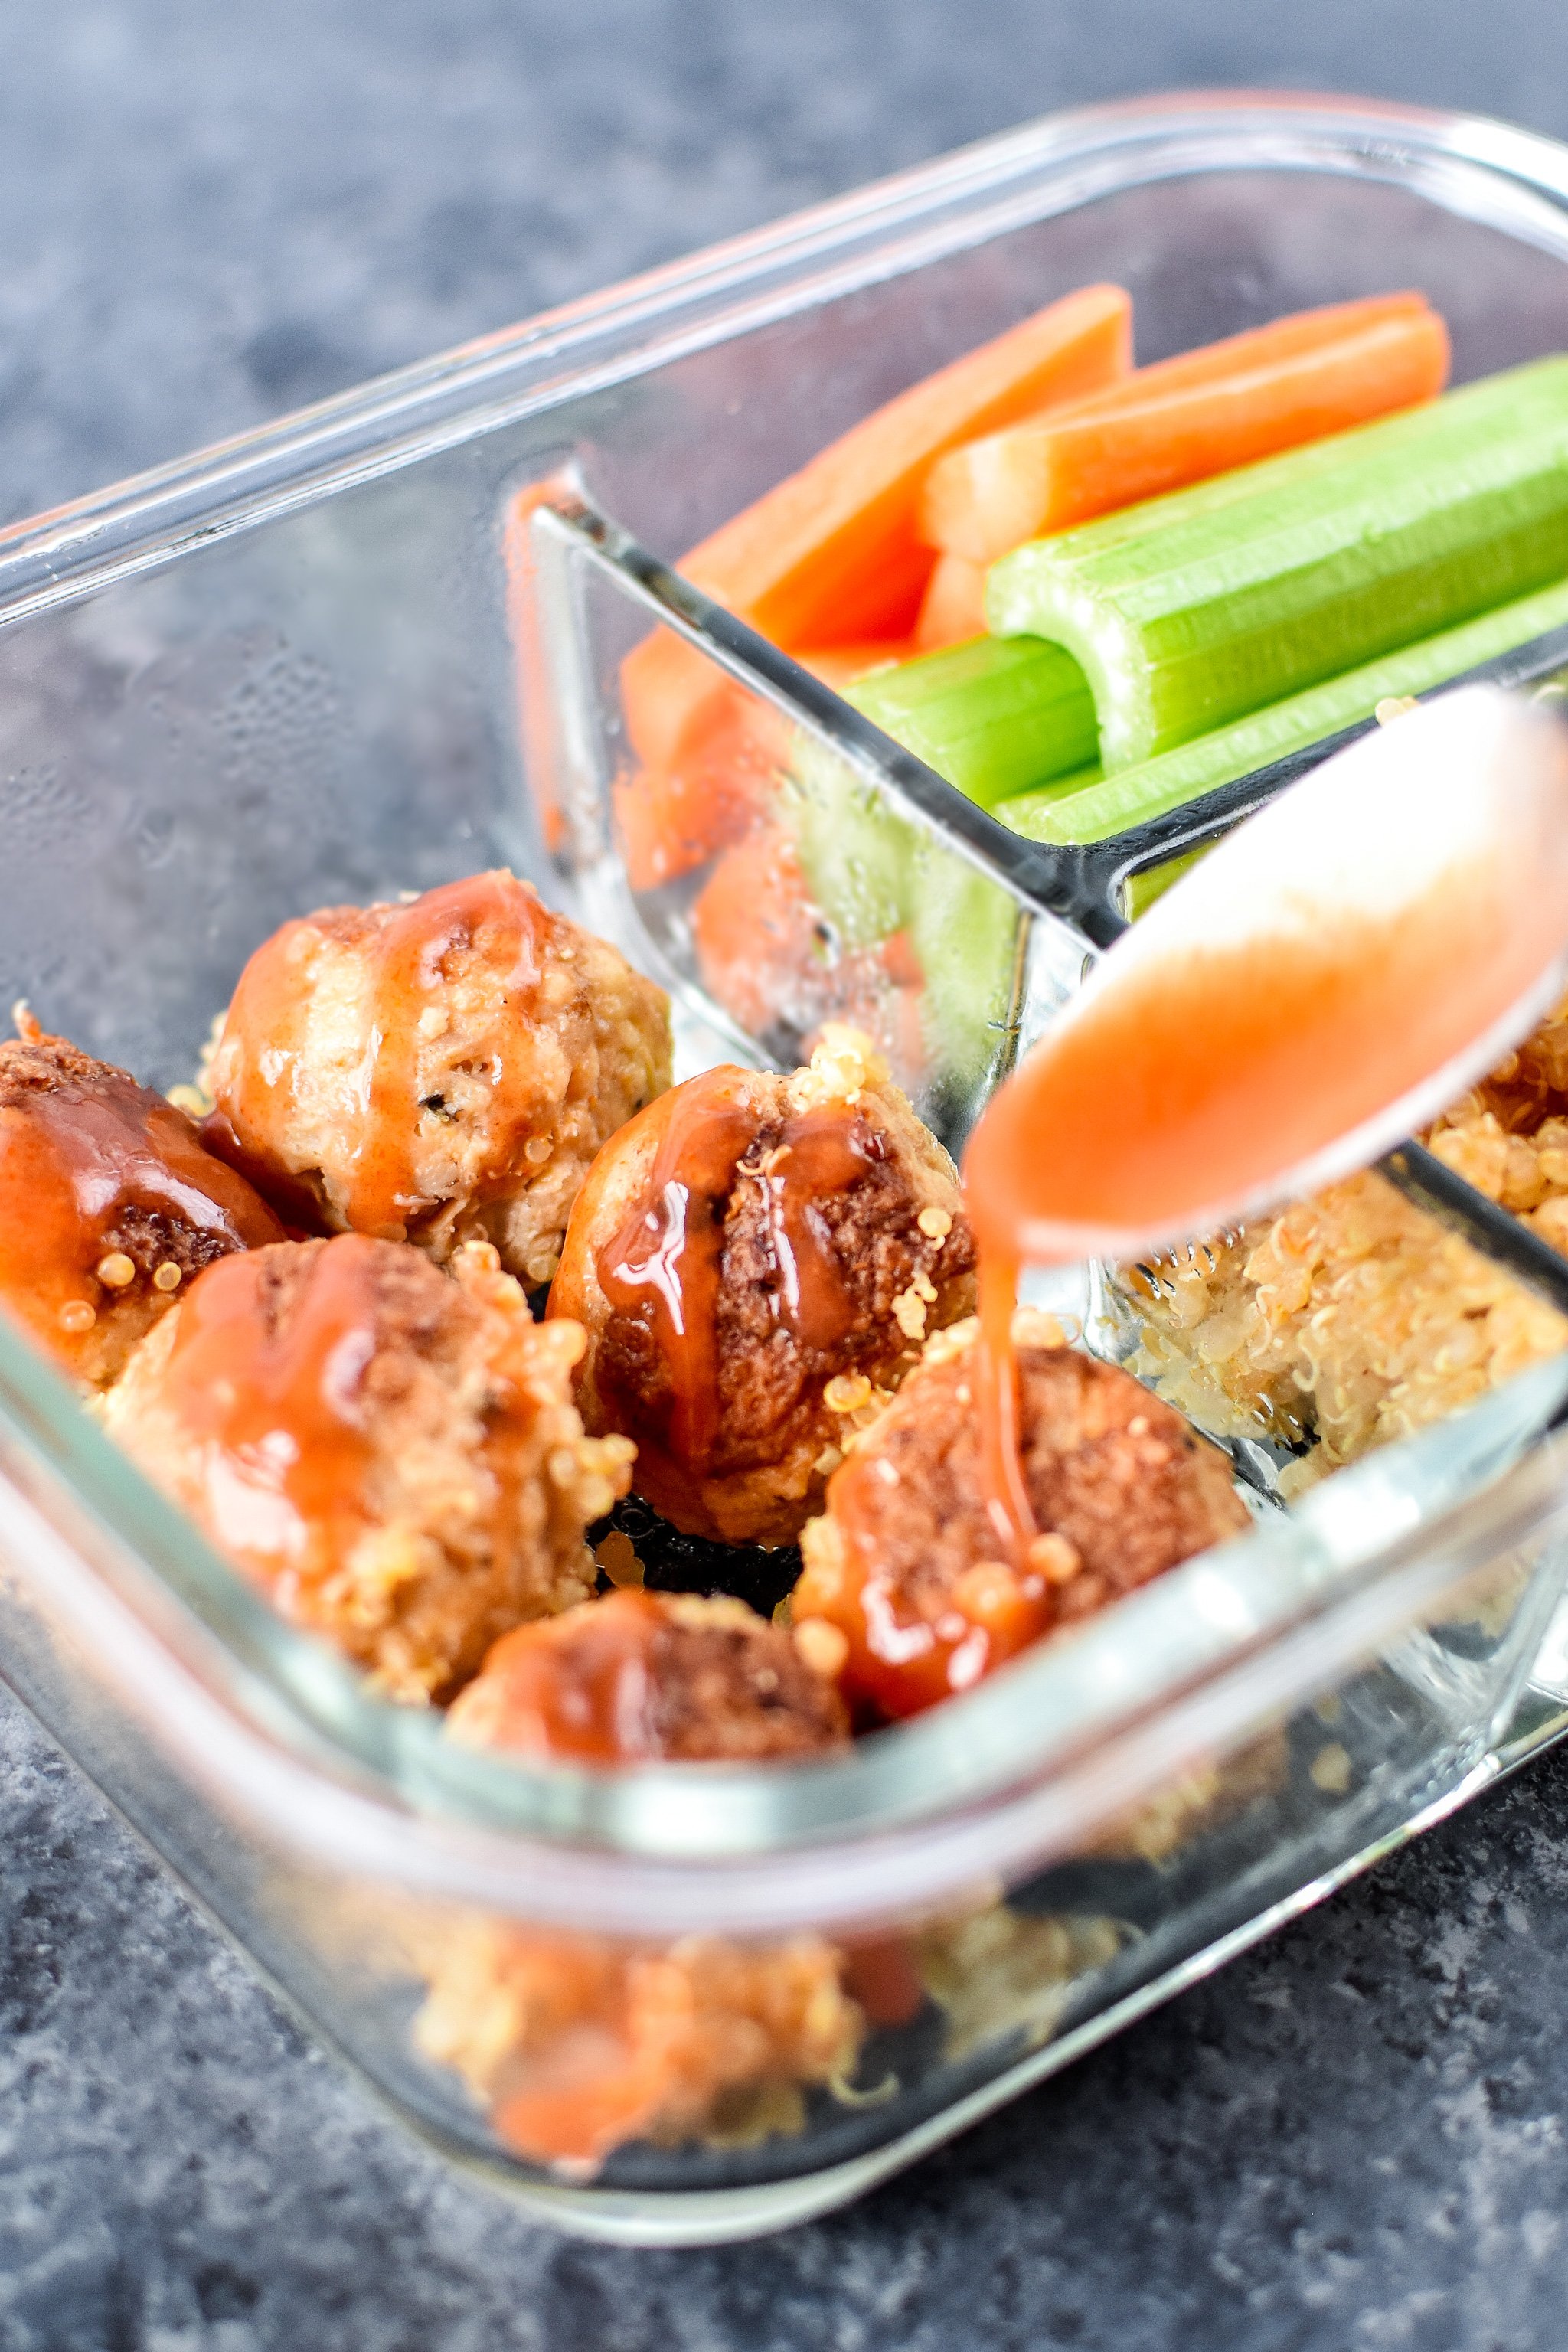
[{"xmin": 995, "ymin": 564, "xmax": 1568, "ymax": 844}]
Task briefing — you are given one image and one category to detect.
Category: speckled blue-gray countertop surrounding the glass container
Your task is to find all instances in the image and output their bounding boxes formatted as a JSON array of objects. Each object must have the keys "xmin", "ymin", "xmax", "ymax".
[{"xmin": 0, "ymin": 0, "xmax": 1568, "ymax": 2352}]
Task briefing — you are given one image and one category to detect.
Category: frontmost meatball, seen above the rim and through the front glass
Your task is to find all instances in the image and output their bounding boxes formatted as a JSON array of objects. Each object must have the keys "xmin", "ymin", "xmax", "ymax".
[{"xmin": 416, "ymin": 1590, "xmax": 867, "ymax": 2171}]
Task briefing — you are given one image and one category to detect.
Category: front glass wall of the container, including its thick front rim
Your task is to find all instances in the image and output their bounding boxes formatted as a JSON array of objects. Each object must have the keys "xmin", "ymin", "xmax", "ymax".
[{"xmin": 0, "ymin": 1289, "xmax": 1568, "ymax": 2242}]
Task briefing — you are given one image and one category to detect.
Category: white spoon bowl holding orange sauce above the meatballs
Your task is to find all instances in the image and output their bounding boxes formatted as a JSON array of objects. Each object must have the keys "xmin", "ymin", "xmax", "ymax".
[{"xmin": 964, "ymin": 687, "xmax": 1568, "ymax": 1263}]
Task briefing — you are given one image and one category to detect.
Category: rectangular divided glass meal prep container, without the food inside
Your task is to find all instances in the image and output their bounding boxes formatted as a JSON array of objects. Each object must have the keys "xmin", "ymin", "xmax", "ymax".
[{"xmin": 0, "ymin": 94, "xmax": 1568, "ymax": 2244}]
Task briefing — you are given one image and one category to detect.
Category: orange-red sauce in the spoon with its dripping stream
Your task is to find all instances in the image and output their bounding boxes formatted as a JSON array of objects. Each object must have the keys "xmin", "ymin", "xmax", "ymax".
[{"xmin": 964, "ymin": 871, "xmax": 1559, "ymax": 1564}]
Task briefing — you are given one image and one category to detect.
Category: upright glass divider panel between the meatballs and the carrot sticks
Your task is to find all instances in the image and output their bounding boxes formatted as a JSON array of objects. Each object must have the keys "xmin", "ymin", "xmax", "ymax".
[{"xmin": 524, "ymin": 487, "xmax": 1032, "ymax": 1145}]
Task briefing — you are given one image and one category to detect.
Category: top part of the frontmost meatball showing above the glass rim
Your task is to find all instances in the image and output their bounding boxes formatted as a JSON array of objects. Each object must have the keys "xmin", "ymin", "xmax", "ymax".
[{"xmin": 449, "ymin": 1592, "xmax": 848, "ymax": 1764}]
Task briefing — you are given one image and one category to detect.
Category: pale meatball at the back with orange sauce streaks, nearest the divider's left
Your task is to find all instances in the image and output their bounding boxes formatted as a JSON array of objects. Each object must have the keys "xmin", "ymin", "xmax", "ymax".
[{"xmin": 207, "ymin": 871, "xmax": 670, "ymax": 1284}]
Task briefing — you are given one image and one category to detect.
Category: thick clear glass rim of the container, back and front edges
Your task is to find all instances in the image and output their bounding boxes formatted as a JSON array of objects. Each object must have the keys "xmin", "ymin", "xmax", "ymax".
[{"xmin": 0, "ymin": 92, "xmax": 1568, "ymax": 1931}]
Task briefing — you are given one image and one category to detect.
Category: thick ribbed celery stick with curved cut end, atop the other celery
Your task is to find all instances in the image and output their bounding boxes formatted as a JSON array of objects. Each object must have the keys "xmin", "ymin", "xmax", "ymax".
[{"xmin": 988, "ymin": 358, "xmax": 1568, "ymax": 776}]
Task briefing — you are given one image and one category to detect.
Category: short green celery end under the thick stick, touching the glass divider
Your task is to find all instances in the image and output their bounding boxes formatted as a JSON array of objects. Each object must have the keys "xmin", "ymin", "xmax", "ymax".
[{"xmin": 844, "ymin": 638, "xmax": 1098, "ymax": 809}]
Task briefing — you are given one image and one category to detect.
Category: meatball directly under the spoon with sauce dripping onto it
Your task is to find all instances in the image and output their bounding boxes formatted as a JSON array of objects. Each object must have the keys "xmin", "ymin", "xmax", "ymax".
[{"xmin": 792, "ymin": 1312, "xmax": 1250, "ymax": 1722}]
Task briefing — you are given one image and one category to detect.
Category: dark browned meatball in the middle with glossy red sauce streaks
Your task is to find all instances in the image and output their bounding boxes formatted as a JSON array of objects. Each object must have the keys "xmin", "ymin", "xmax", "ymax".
[{"xmin": 550, "ymin": 1027, "xmax": 973, "ymax": 1543}]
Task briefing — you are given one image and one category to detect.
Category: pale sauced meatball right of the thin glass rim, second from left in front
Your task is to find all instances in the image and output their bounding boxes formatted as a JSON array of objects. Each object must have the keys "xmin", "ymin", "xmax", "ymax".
[{"xmin": 106, "ymin": 1235, "xmax": 632, "ymax": 1703}]
